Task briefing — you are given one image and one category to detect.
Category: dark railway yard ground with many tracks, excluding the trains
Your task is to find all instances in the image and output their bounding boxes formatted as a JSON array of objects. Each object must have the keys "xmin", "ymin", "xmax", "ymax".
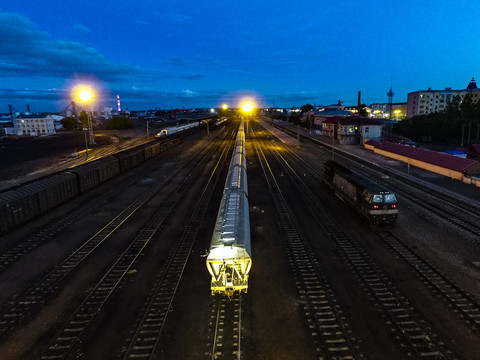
[{"xmin": 0, "ymin": 119, "xmax": 480, "ymax": 360}]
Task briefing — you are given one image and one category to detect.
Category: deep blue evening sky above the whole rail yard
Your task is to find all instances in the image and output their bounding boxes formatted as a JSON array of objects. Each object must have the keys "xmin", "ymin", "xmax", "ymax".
[{"xmin": 0, "ymin": 0, "xmax": 480, "ymax": 113}]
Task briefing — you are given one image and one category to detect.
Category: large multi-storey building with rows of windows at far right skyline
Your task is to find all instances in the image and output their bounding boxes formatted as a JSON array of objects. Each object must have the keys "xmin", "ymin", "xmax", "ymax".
[{"xmin": 407, "ymin": 78, "xmax": 480, "ymax": 118}]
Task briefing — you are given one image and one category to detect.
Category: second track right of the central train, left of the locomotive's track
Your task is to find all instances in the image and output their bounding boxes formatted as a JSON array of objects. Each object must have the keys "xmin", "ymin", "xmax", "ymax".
[{"xmin": 253, "ymin": 123, "xmax": 454, "ymax": 360}]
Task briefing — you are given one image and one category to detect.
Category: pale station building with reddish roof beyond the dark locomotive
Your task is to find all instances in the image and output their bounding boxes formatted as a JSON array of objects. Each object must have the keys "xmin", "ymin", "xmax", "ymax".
[{"xmin": 322, "ymin": 116, "xmax": 382, "ymax": 145}]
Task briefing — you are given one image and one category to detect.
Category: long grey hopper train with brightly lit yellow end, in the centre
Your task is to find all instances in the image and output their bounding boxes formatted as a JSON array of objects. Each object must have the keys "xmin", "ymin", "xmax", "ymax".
[{"xmin": 207, "ymin": 122, "xmax": 252, "ymax": 297}]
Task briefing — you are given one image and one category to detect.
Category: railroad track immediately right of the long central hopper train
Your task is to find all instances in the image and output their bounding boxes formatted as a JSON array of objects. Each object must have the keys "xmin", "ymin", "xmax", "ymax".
[{"xmin": 254, "ymin": 131, "xmax": 362, "ymax": 360}]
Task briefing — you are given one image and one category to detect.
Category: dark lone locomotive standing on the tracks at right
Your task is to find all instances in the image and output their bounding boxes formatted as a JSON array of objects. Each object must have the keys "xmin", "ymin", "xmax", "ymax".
[{"xmin": 322, "ymin": 160, "xmax": 398, "ymax": 226}]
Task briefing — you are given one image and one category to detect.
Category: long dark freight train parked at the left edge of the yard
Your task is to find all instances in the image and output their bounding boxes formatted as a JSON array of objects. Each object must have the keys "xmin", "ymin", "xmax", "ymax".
[{"xmin": 0, "ymin": 138, "xmax": 182, "ymax": 234}]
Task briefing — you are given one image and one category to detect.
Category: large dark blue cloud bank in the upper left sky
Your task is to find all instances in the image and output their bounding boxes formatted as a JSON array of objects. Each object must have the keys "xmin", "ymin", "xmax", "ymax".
[{"xmin": 0, "ymin": 12, "xmax": 202, "ymax": 82}]
